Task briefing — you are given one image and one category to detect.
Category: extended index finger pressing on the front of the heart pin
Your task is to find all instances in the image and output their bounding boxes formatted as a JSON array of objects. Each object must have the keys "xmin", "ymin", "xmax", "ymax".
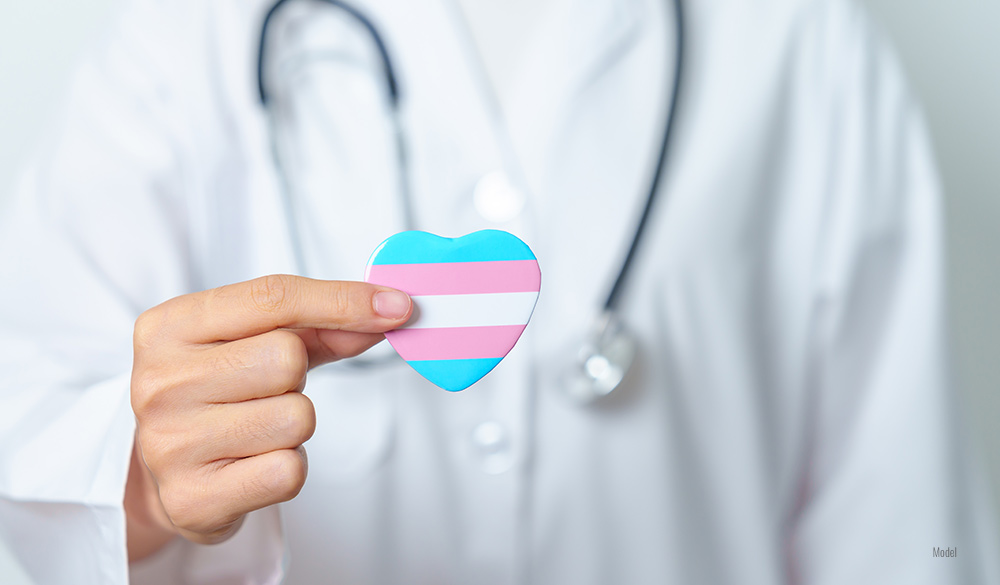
[{"xmin": 149, "ymin": 274, "xmax": 413, "ymax": 343}]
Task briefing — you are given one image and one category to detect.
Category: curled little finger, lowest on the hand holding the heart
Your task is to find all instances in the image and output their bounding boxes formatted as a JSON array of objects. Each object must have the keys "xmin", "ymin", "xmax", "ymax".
[{"xmin": 160, "ymin": 448, "xmax": 308, "ymax": 544}]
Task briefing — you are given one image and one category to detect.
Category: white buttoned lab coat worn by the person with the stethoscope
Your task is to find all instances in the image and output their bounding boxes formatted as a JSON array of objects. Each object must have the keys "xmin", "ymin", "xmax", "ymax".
[{"xmin": 0, "ymin": 0, "xmax": 1000, "ymax": 585}]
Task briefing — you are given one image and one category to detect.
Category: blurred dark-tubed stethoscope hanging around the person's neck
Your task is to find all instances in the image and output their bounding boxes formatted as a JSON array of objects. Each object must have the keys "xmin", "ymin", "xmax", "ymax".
[{"xmin": 257, "ymin": 0, "xmax": 684, "ymax": 403}]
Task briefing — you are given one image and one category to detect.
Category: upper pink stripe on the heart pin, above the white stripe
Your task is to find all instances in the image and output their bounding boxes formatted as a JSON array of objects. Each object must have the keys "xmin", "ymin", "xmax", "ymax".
[{"xmin": 365, "ymin": 260, "xmax": 542, "ymax": 295}]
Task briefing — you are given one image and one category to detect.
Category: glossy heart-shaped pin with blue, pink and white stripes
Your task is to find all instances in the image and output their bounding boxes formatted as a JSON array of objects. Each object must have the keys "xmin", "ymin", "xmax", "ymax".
[{"xmin": 365, "ymin": 230, "xmax": 542, "ymax": 392}]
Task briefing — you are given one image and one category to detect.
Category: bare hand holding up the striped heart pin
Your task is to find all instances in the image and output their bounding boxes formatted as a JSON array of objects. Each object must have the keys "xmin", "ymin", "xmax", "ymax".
[{"xmin": 126, "ymin": 276, "xmax": 412, "ymax": 556}]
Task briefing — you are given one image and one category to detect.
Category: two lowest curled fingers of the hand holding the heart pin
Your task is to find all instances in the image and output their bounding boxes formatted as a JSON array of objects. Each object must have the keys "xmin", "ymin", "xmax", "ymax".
[{"xmin": 140, "ymin": 392, "xmax": 316, "ymax": 543}]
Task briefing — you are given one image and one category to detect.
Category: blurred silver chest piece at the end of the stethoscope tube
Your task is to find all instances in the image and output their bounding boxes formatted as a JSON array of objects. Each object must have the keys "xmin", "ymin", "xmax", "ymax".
[{"xmin": 563, "ymin": 310, "xmax": 636, "ymax": 404}]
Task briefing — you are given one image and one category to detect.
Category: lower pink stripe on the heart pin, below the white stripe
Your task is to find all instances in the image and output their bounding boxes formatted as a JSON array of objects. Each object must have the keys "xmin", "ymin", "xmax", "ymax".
[{"xmin": 385, "ymin": 325, "xmax": 525, "ymax": 360}]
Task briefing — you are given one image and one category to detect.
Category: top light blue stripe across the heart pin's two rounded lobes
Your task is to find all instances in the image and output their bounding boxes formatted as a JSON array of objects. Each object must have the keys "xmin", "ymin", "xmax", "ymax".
[{"xmin": 369, "ymin": 230, "xmax": 535, "ymax": 264}]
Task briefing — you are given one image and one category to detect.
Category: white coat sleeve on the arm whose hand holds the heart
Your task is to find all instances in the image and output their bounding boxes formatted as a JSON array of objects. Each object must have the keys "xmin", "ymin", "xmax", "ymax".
[{"xmin": 0, "ymin": 0, "xmax": 283, "ymax": 585}]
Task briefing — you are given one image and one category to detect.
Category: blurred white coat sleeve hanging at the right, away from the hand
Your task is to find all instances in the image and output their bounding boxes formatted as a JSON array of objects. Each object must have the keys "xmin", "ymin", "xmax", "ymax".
[{"xmin": 790, "ymin": 2, "xmax": 1000, "ymax": 585}]
